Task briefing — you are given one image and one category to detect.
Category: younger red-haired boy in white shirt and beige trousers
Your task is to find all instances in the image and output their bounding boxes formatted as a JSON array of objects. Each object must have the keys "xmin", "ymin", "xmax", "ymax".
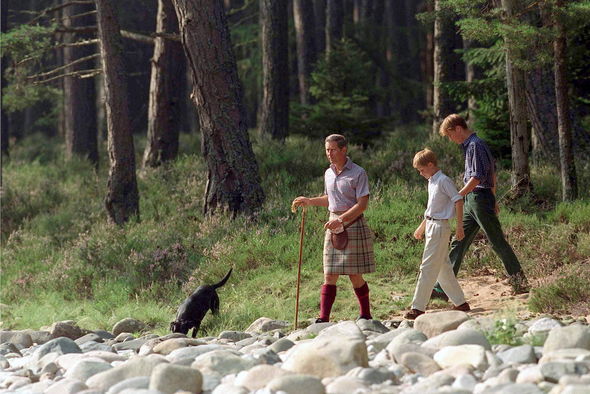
[{"xmin": 404, "ymin": 149, "xmax": 471, "ymax": 320}]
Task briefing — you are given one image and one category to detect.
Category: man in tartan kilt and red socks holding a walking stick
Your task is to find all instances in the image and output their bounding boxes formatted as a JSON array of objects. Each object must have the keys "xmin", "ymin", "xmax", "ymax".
[{"xmin": 293, "ymin": 134, "xmax": 375, "ymax": 323}]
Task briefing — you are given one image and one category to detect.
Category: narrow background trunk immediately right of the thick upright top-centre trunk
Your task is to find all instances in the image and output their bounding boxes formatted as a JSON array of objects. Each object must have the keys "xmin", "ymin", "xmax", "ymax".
[{"xmin": 294, "ymin": 0, "xmax": 317, "ymax": 104}]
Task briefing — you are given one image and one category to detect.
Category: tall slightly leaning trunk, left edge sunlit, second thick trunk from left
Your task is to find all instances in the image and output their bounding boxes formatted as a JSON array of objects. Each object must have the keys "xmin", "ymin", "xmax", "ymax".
[{"xmin": 96, "ymin": 0, "xmax": 139, "ymax": 224}]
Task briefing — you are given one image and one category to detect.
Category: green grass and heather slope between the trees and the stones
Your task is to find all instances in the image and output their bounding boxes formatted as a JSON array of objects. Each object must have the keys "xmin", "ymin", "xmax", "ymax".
[{"xmin": 0, "ymin": 128, "xmax": 590, "ymax": 335}]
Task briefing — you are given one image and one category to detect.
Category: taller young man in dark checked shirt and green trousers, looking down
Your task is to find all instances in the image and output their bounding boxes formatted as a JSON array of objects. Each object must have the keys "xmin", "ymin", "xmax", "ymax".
[{"xmin": 432, "ymin": 114, "xmax": 528, "ymax": 299}]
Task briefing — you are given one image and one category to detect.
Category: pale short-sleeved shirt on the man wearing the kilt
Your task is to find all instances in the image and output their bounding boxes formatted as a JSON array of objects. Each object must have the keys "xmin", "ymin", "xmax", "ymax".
[{"xmin": 324, "ymin": 158, "xmax": 369, "ymax": 212}]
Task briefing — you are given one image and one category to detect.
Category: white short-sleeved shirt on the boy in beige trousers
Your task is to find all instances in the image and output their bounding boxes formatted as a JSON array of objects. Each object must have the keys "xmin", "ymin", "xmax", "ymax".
[{"xmin": 424, "ymin": 170, "xmax": 463, "ymax": 219}]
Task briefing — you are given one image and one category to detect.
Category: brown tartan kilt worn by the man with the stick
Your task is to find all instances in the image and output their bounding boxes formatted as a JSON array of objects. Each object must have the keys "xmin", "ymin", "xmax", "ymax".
[{"xmin": 324, "ymin": 212, "xmax": 375, "ymax": 275}]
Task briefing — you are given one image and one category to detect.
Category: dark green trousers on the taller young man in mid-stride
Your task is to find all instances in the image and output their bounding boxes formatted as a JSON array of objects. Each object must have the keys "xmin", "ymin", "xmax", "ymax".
[{"xmin": 434, "ymin": 189, "xmax": 522, "ymax": 293}]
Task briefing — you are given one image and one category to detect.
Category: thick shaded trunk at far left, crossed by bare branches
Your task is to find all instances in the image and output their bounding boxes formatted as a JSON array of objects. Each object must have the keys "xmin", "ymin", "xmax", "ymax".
[{"xmin": 63, "ymin": 0, "xmax": 98, "ymax": 166}]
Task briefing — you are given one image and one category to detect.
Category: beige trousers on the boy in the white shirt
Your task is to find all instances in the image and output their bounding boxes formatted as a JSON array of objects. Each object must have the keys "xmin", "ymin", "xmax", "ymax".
[{"xmin": 412, "ymin": 220, "xmax": 465, "ymax": 311}]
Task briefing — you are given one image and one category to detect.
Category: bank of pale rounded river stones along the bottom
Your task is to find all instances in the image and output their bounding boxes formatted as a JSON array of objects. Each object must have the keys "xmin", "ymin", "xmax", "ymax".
[{"xmin": 0, "ymin": 311, "xmax": 590, "ymax": 394}]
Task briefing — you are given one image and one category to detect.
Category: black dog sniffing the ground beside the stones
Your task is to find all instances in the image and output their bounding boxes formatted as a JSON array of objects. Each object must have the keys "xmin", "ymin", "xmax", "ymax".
[{"xmin": 170, "ymin": 269, "xmax": 232, "ymax": 338}]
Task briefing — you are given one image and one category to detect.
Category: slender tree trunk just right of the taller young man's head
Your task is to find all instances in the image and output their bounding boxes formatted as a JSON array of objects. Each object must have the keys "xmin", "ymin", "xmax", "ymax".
[{"xmin": 502, "ymin": 0, "xmax": 532, "ymax": 196}]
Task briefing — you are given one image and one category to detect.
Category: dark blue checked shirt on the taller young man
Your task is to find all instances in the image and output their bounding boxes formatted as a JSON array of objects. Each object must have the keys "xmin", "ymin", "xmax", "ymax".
[{"xmin": 461, "ymin": 133, "xmax": 496, "ymax": 189}]
